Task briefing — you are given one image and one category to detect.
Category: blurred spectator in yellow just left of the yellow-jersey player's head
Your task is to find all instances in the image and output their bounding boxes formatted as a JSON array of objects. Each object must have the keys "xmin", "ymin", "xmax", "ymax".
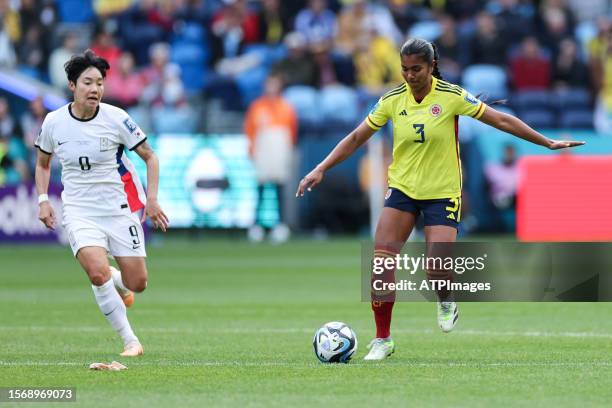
[{"xmin": 354, "ymin": 32, "xmax": 403, "ymax": 96}]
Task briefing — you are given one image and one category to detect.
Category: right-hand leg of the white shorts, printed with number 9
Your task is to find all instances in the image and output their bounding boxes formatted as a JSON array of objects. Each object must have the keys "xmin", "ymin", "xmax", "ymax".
[{"xmin": 104, "ymin": 214, "xmax": 147, "ymax": 258}]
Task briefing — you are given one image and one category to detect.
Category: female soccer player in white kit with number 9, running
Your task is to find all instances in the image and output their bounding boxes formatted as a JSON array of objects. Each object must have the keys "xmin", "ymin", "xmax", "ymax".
[{"xmin": 35, "ymin": 50, "xmax": 168, "ymax": 356}]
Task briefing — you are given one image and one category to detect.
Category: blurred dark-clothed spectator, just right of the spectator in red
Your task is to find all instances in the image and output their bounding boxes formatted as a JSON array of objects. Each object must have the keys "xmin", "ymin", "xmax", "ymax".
[{"xmin": 553, "ymin": 38, "xmax": 590, "ymax": 88}]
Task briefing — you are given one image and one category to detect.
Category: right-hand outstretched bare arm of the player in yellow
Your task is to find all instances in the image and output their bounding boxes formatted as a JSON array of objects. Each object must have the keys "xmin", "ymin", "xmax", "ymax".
[{"xmin": 479, "ymin": 106, "xmax": 585, "ymax": 150}]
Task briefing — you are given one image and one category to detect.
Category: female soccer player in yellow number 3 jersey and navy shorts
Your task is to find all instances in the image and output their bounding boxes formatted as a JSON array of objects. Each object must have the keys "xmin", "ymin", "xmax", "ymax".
[{"xmin": 296, "ymin": 39, "xmax": 584, "ymax": 360}]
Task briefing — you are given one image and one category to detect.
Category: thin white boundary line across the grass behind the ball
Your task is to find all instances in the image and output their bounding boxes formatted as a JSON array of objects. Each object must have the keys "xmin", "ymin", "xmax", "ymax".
[{"xmin": 0, "ymin": 326, "xmax": 612, "ymax": 339}]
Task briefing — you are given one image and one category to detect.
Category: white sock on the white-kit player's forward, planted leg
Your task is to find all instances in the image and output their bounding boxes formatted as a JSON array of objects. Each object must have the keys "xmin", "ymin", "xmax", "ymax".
[{"xmin": 91, "ymin": 279, "xmax": 138, "ymax": 345}]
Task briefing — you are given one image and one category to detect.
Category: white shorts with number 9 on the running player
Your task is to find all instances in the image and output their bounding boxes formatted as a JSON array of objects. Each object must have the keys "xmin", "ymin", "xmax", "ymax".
[{"xmin": 63, "ymin": 214, "xmax": 147, "ymax": 257}]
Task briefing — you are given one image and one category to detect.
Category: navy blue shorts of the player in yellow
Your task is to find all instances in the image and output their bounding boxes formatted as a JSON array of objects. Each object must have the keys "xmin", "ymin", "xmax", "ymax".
[{"xmin": 385, "ymin": 188, "xmax": 461, "ymax": 229}]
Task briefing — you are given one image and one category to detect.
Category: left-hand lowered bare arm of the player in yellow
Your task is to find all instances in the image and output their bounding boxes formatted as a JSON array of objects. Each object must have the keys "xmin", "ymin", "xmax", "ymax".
[{"xmin": 295, "ymin": 121, "xmax": 376, "ymax": 197}]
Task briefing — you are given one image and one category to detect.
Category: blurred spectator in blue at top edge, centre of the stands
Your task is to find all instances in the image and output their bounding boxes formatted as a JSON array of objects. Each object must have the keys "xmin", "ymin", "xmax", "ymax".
[{"xmin": 295, "ymin": 0, "xmax": 336, "ymax": 43}]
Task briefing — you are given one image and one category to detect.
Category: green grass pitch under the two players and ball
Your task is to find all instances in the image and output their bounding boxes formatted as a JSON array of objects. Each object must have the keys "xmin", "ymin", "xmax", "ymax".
[{"xmin": 0, "ymin": 240, "xmax": 612, "ymax": 408}]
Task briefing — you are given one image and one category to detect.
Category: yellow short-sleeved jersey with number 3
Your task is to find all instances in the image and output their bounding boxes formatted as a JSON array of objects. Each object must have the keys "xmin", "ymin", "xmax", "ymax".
[{"xmin": 366, "ymin": 77, "xmax": 486, "ymax": 200}]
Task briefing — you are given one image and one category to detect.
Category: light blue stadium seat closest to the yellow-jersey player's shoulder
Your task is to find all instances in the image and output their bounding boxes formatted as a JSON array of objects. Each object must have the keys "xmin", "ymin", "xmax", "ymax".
[{"xmin": 319, "ymin": 85, "xmax": 359, "ymax": 124}]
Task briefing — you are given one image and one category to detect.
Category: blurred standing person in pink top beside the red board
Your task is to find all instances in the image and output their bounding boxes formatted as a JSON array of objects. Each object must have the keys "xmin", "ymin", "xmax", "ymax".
[{"xmin": 484, "ymin": 144, "xmax": 518, "ymax": 231}]
